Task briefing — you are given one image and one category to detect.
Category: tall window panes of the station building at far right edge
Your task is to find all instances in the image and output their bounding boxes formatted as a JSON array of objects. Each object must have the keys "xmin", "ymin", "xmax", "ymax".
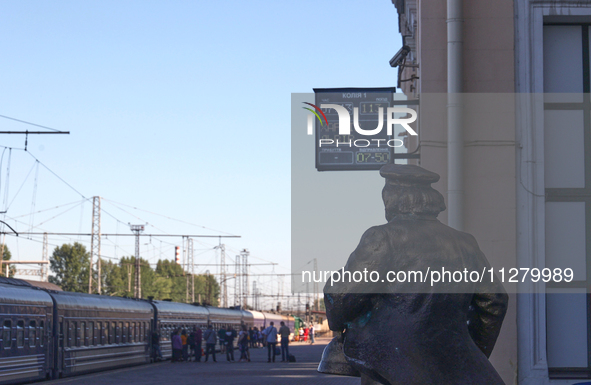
[{"xmin": 543, "ymin": 24, "xmax": 591, "ymax": 378}]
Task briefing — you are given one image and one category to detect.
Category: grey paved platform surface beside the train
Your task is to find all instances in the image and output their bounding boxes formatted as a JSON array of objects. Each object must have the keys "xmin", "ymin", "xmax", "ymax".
[{"xmin": 41, "ymin": 339, "xmax": 361, "ymax": 385}]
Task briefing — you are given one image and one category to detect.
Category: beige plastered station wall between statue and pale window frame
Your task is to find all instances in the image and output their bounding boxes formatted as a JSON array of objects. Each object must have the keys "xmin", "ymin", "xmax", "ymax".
[{"xmin": 395, "ymin": 0, "xmax": 517, "ymax": 384}]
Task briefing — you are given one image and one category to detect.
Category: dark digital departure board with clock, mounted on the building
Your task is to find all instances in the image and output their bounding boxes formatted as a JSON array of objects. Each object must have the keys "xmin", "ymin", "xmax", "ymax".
[{"xmin": 314, "ymin": 87, "xmax": 401, "ymax": 171}]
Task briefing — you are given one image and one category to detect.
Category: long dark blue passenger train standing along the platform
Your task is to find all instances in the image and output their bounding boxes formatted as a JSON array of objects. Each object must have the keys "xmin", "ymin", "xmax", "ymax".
[{"xmin": 0, "ymin": 278, "xmax": 294, "ymax": 385}]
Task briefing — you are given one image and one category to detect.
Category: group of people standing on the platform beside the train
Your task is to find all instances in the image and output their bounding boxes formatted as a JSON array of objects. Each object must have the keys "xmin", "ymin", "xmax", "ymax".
[{"xmin": 152, "ymin": 321, "xmax": 314, "ymax": 362}]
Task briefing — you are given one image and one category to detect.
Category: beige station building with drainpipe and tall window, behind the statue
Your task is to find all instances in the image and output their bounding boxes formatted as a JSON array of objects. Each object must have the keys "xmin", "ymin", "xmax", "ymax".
[{"xmin": 392, "ymin": 0, "xmax": 591, "ymax": 385}]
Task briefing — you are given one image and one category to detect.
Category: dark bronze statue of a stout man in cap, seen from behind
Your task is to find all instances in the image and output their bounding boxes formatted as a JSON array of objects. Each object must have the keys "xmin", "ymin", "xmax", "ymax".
[{"xmin": 318, "ymin": 164, "xmax": 508, "ymax": 385}]
